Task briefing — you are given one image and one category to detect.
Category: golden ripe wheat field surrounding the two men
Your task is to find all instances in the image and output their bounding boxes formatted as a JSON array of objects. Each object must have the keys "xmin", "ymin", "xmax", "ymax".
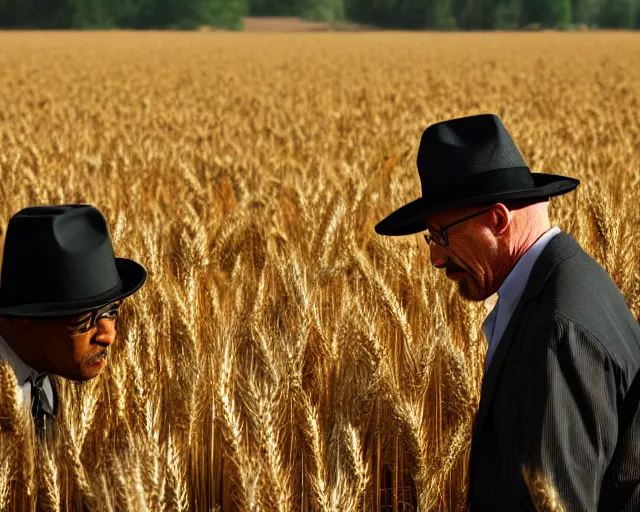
[{"xmin": 0, "ymin": 32, "xmax": 640, "ymax": 512}]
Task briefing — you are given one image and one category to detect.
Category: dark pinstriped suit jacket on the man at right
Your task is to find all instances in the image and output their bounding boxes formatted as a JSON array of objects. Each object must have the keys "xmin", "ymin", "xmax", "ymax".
[{"xmin": 469, "ymin": 233, "xmax": 640, "ymax": 512}]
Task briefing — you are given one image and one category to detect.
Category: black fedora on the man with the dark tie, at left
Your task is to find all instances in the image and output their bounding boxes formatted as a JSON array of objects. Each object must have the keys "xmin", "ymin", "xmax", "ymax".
[{"xmin": 0, "ymin": 204, "xmax": 147, "ymax": 317}]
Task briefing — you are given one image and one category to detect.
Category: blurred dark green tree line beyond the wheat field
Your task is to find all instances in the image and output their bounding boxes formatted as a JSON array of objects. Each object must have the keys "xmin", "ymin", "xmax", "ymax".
[{"xmin": 0, "ymin": 0, "xmax": 640, "ymax": 30}]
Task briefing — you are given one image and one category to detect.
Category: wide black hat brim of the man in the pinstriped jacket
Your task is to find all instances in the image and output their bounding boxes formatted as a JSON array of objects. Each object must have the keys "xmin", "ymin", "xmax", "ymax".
[{"xmin": 375, "ymin": 173, "xmax": 580, "ymax": 236}]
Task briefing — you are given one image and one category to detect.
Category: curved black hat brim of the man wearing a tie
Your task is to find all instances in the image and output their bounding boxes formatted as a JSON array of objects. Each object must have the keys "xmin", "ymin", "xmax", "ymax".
[{"xmin": 0, "ymin": 258, "xmax": 147, "ymax": 318}]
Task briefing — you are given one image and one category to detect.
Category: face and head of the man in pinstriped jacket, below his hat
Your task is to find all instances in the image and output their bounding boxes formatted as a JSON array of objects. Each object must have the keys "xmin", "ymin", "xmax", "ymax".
[{"xmin": 426, "ymin": 201, "xmax": 551, "ymax": 301}]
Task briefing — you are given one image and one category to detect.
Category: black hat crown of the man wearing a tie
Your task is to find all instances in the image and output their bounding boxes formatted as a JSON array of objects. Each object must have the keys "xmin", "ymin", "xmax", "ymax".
[{"xmin": 0, "ymin": 205, "xmax": 121, "ymax": 310}]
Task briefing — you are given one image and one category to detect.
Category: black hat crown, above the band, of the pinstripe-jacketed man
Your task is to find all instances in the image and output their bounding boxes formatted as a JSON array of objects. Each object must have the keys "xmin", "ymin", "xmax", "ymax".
[{"xmin": 417, "ymin": 114, "xmax": 533, "ymax": 196}]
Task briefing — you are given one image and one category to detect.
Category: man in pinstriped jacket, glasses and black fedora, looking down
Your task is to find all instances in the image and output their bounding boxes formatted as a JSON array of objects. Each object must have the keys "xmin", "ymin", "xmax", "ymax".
[{"xmin": 376, "ymin": 115, "xmax": 640, "ymax": 512}]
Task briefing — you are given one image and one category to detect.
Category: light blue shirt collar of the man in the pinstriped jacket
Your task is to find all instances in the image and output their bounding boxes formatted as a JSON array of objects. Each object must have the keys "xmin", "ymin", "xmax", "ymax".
[{"xmin": 482, "ymin": 226, "xmax": 560, "ymax": 371}]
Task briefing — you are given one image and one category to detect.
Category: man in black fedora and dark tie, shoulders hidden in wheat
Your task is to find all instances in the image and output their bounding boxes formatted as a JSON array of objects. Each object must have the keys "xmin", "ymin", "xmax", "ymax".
[{"xmin": 0, "ymin": 205, "xmax": 146, "ymax": 433}]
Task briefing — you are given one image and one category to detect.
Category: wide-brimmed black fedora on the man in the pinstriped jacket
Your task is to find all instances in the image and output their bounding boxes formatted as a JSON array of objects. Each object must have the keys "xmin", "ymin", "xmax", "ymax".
[{"xmin": 375, "ymin": 114, "xmax": 580, "ymax": 236}]
